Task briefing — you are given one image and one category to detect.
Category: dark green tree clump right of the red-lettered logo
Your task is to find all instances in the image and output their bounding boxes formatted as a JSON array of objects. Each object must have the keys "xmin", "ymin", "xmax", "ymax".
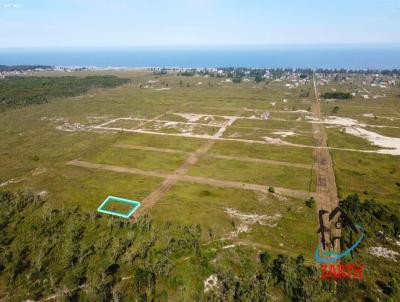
[{"xmin": 340, "ymin": 194, "xmax": 400, "ymax": 301}]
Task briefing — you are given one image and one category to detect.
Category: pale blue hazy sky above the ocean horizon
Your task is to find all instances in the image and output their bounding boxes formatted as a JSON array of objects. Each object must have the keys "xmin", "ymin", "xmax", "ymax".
[{"xmin": 0, "ymin": 0, "xmax": 400, "ymax": 48}]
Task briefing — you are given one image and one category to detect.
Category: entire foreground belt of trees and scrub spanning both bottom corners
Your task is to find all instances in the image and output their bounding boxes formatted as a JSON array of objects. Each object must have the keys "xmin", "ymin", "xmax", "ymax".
[{"xmin": 0, "ymin": 190, "xmax": 400, "ymax": 301}]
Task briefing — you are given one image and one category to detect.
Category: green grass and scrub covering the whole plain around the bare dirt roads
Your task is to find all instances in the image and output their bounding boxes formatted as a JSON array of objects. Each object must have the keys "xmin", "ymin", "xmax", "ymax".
[{"xmin": 0, "ymin": 69, "xmax": 400, "ymax": 302}]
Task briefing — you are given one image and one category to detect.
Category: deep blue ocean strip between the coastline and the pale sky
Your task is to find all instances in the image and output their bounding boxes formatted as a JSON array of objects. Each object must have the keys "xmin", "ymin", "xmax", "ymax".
[{"xmin": 0, "ymin": 47, "xmax": 400, "ymax": 69}]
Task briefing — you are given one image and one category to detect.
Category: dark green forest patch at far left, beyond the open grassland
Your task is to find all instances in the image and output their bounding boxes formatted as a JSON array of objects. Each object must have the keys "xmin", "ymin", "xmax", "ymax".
[{"xmin": 0, "ymin": 76, "xmax": 129, "ymax": 110}]
